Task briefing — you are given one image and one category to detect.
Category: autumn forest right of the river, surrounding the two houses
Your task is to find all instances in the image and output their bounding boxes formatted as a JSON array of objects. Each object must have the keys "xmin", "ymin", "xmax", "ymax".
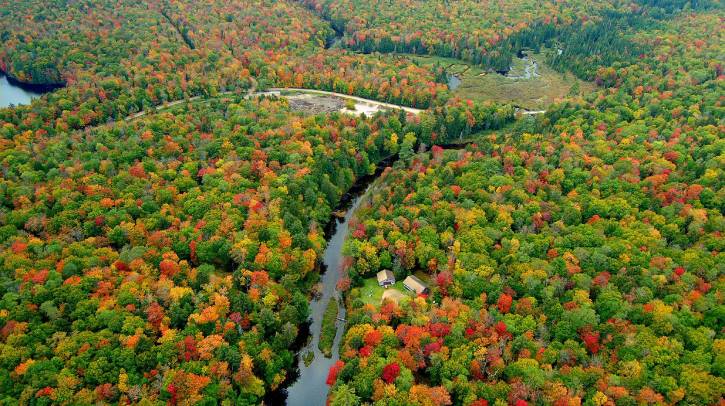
[{"xmin": 328, "ymin": 9, "xmax": 725, "ymax": 405}]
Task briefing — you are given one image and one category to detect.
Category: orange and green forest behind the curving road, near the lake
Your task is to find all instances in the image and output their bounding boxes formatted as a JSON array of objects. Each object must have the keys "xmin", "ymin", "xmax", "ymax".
[{"xmin": 0, "ymin": 0, "xmax": 447, "ymax": 138}]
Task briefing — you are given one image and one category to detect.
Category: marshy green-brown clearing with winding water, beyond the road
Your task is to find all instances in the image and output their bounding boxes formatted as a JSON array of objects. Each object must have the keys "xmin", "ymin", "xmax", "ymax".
[{"xmin": 409, "ymin": 54, "xmax": 596, "ymax": 110}]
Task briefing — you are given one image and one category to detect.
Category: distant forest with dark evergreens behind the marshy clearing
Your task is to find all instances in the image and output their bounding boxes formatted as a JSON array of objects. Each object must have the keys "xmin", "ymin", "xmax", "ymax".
[{"xmin": 299, "ymin": 0, "xmax": 718, "ymax": 80}]
